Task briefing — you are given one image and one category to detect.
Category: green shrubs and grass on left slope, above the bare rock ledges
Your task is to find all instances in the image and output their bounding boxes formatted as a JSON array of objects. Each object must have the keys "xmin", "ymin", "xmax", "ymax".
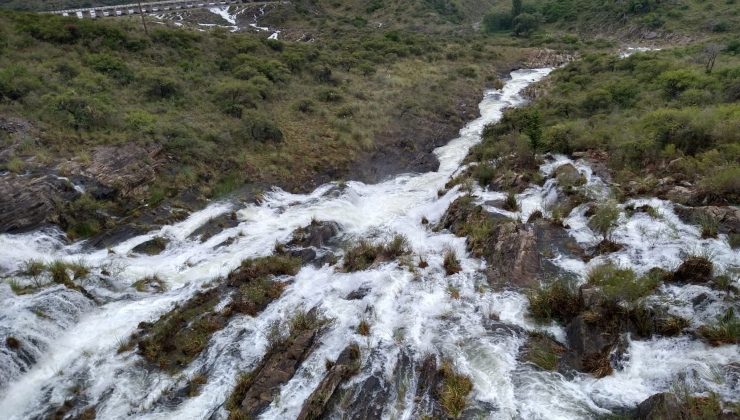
[{"xmin": 0, "ymin": 8, "xmax": 502, "ymax": 226}]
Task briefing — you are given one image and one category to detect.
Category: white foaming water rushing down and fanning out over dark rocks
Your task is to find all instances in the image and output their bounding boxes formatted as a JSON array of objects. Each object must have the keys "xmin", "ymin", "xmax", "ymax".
[{"xmin": 0, "ymin": 69, "xmax": 740, "ymax": 419}]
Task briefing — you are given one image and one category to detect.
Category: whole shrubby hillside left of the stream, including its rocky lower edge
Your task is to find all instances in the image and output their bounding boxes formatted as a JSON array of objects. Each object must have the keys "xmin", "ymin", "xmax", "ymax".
[{"xmin": 0, "ymin": 7, "xmax": 529, "ymax": 237}]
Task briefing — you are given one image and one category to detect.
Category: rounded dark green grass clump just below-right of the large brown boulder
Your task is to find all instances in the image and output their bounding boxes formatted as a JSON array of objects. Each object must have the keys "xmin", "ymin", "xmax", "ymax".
[{"xmin": 527, "ymin": 278, "xmax": 581, "ymax": 323}]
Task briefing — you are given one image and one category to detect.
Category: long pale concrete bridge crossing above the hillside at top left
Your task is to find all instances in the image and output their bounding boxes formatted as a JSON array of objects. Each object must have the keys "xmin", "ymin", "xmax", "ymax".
[{"xmin": 49, "ymin": 0, "xmax": 281, "ymax": 19}]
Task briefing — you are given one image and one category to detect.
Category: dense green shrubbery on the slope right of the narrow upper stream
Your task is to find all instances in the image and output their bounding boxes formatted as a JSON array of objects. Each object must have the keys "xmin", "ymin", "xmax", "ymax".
[{"xmin": 473, "ymin": 50, "xmax": 740, "ymax": 202}]
